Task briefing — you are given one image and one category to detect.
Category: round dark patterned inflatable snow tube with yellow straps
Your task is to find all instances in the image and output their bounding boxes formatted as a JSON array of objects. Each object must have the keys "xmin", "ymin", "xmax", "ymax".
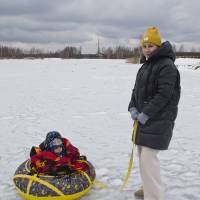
[{"xmin": 13, "ymin": 160, "xmax": 95, "ymax": 200}]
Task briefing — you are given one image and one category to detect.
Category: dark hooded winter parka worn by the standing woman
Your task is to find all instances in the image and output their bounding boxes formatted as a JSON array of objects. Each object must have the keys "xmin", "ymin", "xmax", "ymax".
[{"xmin": 128, "ymin": 42, "xmax": 180, "ymax": 150}]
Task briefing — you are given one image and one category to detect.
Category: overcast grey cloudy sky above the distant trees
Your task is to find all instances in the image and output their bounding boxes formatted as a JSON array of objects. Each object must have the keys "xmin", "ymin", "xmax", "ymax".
[{"xmin": 0, "ymin": 0, "xmax": 200, "ymax": 53}]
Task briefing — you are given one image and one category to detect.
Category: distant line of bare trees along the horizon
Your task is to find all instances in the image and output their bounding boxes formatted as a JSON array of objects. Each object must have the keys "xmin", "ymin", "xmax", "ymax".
[{"xmin": 0, "ymin": 45, "xmax": 200, "ymax": 59}]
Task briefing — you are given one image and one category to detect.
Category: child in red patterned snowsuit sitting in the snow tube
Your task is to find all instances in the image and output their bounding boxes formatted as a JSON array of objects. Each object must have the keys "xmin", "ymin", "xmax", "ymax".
[{"xmin": 30, "ymin": 131, "xmax": 88, "ymax": 175}]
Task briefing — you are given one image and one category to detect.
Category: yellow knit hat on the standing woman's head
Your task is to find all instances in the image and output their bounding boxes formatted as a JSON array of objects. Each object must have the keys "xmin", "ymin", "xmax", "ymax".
[{"xmin": 141, "ymin": 26, "xmax": 161, "ymax": 46}]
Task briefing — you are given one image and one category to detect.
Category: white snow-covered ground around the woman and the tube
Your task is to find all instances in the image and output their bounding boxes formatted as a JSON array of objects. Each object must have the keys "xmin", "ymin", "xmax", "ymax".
[{"xmin": 0, "ymin": 59, "xmax": 200, "ymax": 200}]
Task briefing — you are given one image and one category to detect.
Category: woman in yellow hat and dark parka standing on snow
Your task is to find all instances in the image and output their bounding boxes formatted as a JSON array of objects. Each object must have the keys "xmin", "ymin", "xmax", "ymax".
[{"xmin": 128, "ymin": 27, "xmax": 180, "ymax": 200}]
